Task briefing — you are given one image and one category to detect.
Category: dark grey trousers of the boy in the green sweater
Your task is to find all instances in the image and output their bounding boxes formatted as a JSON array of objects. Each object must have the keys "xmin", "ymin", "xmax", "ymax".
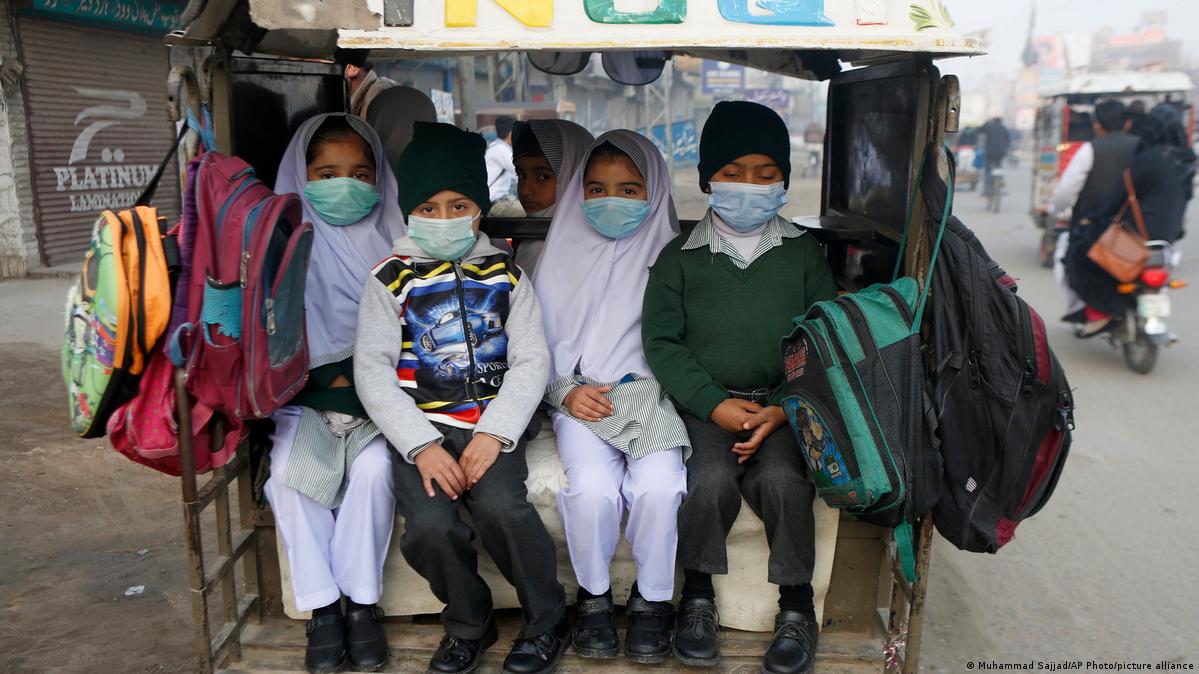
[{"xmin": 679, "ymin": 413, "xmax": 815, "ymax": 585}]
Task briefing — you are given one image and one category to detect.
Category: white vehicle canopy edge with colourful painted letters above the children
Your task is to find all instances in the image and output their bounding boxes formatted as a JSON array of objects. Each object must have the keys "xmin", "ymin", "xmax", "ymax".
[{"xmin": 168, "ymin": 0, "xmax": 982, "ymax": 79}]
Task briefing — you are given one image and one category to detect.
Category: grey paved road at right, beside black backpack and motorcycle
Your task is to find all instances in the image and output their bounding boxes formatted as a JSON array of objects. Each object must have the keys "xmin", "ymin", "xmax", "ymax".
[{"xmin": 922, "ymin": 166, "xmax": 1199, "ymax": 672}]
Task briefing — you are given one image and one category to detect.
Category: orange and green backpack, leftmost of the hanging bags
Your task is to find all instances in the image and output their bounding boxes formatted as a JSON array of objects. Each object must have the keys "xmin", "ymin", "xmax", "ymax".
[{"xmin": 62, "ymin": 205, "xmax": 170, "ymax": 438}]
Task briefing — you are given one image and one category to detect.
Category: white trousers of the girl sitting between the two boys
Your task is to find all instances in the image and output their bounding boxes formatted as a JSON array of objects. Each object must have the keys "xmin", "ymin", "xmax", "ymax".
[{"xmin": 554, "ymin": 414, "xmax": 687, "ymax": 601}]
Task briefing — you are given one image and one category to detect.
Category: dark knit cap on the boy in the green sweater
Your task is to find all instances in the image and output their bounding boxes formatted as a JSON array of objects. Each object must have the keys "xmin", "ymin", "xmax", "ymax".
[{"xmin": 699, "ymin": 101, "xmax": 791, "ymax": 192}]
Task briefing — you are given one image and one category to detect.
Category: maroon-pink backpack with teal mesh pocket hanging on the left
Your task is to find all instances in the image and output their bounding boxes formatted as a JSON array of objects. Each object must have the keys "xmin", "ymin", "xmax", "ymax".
[{"xmin": 171, "ymin": 152, "xmax": 313, "ymax": 422}]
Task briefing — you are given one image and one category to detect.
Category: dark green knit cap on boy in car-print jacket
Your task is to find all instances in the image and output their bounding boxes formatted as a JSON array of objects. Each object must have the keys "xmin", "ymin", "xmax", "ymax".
[{"xmin": 396, "ymin": 121, "xmax": 492, "ymax": 217}]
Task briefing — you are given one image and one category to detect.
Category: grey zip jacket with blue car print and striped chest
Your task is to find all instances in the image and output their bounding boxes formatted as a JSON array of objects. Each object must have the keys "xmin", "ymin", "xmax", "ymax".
[{"xmin": 354, "ymin": 234, "xmax": 549, "ymax": 463}]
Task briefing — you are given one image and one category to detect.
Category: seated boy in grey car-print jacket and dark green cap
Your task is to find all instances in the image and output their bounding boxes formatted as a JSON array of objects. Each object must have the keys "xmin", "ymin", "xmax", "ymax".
[{"xmin": 354, "ymin": 122, "xmax": 568, "ymax": 674}]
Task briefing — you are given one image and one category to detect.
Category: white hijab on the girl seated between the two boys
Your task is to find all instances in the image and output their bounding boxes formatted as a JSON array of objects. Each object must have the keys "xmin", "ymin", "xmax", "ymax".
[{"xmin": 534, "ymin": 131, "xmax": 679, "ymax": 381}]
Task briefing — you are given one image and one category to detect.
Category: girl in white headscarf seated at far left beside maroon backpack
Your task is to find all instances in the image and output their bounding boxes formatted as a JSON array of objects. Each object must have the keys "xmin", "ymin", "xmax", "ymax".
[{"xmin": 266, "ymin": 114, "xmax": 411, "ymax": 672}]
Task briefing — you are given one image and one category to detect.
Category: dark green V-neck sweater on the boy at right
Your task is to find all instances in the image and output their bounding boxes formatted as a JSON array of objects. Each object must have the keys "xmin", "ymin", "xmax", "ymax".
[{"xmin": 641, "ymin": 233, "xmax": 837, "ymax": 419}]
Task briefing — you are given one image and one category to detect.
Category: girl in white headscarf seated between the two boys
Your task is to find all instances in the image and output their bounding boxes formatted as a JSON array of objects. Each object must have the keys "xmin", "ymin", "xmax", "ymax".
[{"xmin": 534, "ymin": 131, "xmax": 689, "ymax": 662}]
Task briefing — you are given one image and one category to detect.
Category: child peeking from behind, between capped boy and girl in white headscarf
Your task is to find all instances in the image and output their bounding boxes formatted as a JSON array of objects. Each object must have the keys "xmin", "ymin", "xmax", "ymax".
[{"xmin": 512, "ymin": 120, "xmax": 595, "ymax": 273}]
